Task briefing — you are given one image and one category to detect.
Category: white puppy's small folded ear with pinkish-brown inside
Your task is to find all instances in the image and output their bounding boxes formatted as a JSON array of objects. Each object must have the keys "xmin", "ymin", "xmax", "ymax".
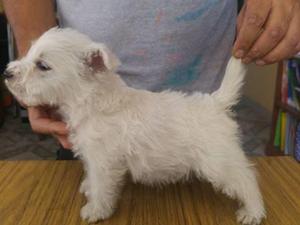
[{"xmin": 85, "ymin": 43, "xmax": 121, "ymax": 72}]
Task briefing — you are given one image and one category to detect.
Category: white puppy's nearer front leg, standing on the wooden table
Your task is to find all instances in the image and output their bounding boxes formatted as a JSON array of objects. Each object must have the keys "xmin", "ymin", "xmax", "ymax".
[{"xmin": 81, "ymin": 158, "xmax": 126, "ymax": 223}]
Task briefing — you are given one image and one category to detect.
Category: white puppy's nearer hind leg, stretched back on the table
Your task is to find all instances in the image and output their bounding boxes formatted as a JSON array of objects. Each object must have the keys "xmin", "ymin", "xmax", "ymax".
[{"xmin": 194, "ymin": 145, "xmax": 265, "ymax": 225}]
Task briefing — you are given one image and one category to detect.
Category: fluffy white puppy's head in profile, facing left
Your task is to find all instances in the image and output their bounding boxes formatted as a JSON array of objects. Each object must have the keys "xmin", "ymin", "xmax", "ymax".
[{"xmin": 3, "ymin": 28, "xmax": 120, "ymax": 106}]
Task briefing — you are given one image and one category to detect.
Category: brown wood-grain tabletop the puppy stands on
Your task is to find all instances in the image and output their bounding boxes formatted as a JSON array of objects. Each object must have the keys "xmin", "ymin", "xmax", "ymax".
[{"xmin": 0, "ymin": 157, "xmax": 300, "ymax": 225}]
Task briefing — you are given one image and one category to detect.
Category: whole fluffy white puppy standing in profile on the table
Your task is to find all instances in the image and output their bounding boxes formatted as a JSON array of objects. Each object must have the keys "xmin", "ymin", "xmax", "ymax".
[{"xmin": 4, "ymin": 28, "xmax": 265, "ymax": 224}]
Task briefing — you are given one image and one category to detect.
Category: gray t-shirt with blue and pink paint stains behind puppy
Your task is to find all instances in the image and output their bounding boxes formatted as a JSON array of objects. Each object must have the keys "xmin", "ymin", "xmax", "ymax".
[{"xmin": 56, "ymin": 0, "xmax": 237, "ymax": 92}]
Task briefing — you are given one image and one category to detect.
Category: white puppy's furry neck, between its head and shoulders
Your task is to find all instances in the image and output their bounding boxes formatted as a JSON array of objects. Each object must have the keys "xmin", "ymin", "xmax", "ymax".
[{"xmin": 59, "ymin": 73, "xmax": 130, "ymax": 127}]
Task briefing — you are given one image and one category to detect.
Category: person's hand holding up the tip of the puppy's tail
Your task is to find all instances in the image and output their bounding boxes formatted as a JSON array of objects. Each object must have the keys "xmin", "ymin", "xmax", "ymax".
[{"xmin": 233, "ymin": 0, "xmax": 300, "ymax": 65}]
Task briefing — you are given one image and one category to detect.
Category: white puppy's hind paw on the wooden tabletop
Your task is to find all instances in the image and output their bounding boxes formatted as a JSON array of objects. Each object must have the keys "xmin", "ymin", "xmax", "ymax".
[{"xmin": 236, "ymin": 207, "xmax": 265, "ymax": 225}]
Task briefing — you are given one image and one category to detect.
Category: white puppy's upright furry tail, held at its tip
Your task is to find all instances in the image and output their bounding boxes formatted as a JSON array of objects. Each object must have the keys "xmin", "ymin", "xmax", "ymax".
[{"xmin": 212, "ymin": 57, "xmax": 247, "ymax": 109}]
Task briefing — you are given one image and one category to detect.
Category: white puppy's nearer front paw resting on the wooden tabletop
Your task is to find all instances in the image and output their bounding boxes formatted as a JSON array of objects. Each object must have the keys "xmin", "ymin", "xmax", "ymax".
[{"xmin": 80, "ymin": 203, "xmax": 113, "ymax": 223}]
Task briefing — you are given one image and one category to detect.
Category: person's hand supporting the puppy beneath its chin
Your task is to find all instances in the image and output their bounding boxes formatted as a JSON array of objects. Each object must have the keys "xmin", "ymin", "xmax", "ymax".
[{"xmin": 28, "ymin": 106, "xmax": 72, "ymax": 149}]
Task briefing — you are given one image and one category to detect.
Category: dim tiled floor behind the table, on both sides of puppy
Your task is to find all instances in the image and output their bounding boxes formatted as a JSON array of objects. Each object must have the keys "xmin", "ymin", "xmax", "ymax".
[{"xmin": 0, "ymin": 98, "xmax": 271, "ymax": 160}]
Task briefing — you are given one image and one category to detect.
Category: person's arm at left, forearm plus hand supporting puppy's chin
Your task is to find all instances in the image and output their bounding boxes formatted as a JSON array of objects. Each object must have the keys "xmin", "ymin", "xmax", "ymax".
[{"xmin": 3, "ymin": 0, "xmax": 71, "ymax": 148}]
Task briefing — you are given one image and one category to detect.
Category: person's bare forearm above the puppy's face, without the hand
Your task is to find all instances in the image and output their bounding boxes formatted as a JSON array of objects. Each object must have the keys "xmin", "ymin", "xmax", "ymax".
[{"xmin": 3, "ymin": 0, "xmax": 56, "ymax": 56}]
